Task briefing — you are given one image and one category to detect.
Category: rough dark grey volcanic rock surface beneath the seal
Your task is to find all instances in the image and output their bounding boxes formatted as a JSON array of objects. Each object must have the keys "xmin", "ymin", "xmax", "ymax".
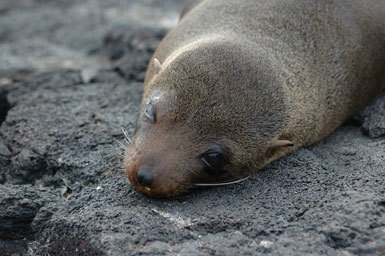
[{"xmin": 0, "ymin": 0, "xmax": 385, "ymax": 255}]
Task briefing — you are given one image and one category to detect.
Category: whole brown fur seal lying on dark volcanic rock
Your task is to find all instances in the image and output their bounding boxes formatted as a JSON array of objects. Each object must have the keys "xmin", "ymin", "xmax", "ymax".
[{"xmin": 124, "ymin": 0, "xmax": 385, "ymax": 197}]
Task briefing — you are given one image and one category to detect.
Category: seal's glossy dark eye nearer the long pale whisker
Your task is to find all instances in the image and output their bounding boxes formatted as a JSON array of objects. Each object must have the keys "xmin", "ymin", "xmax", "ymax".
[{"xmin": 201, "ymin": 143, "xmax": 226, "ymax": 175}]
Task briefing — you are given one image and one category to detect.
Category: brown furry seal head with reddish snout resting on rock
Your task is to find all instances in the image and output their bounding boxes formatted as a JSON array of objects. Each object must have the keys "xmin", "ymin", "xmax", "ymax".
[{"xmin": 124, "ymin": 38, "xmax": 292, "ymax": 197}]
